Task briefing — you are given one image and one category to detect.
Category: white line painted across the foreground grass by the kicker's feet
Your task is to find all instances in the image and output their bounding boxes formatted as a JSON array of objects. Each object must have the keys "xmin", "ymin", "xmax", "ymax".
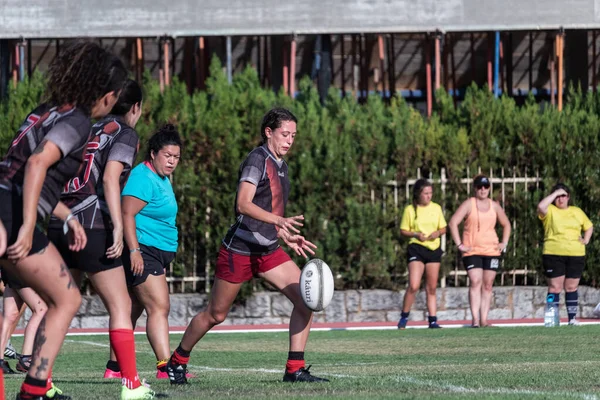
[{"xmin": 65, "ymin": 339, "xmax": 600, "ymax": 400}]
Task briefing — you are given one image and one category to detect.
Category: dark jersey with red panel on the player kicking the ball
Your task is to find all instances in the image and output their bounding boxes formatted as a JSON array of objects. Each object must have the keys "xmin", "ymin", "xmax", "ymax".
[{"xmin": 223, "ymin": 144, "xmax": 290, "ymax": 255}]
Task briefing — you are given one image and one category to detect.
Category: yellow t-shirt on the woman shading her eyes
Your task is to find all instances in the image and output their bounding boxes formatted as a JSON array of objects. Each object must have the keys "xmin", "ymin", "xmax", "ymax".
[{"xmin": 538, "ymin": 204, "xmax": 592, "ymax": 256}]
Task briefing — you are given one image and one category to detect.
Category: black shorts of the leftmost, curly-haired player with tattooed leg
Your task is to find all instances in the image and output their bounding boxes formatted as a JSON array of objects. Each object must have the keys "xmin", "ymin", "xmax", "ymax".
[{"xmin": 0, "ymin": 189, "xmax": 48, "ymax": 259}]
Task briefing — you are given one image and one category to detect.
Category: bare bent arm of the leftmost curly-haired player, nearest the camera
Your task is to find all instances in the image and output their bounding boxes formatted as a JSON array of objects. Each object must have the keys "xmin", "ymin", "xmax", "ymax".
[{"xmin": 7, "ymin": 140, "xmax": 61, "ymax": 262}]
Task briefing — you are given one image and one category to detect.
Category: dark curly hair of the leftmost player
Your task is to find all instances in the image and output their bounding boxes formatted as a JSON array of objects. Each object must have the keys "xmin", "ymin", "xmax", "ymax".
[{"xmin": 45, "ymin": 40, "xmax": 127, "ymax": 114}]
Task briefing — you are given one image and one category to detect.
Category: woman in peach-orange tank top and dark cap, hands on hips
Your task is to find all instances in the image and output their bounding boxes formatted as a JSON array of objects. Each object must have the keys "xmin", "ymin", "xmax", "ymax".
[{"xmin": 448, "ymin": 175, "xmax": 511, "ymax": 328}]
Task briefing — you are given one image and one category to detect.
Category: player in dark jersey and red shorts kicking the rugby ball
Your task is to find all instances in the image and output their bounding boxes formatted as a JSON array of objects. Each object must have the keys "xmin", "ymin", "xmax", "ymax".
[{"xmin": 167, "ymin": 108, "xmax": 327, "ymax": 384}]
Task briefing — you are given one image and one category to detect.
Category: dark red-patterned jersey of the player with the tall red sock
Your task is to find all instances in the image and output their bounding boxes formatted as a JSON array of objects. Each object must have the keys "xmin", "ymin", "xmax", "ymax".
[{"xmin": 50, "ymin": 115, "xmax": 139, "ymax": 229}]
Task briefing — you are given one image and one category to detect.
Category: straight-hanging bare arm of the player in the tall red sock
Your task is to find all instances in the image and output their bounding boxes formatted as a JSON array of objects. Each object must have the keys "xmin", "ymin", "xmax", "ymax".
[{"xmin": 102, "ymin": 161, "xmax": 125, "ymax": 258}]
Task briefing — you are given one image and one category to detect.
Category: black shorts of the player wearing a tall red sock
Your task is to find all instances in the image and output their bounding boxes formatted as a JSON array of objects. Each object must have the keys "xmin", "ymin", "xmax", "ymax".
[{"xmin": 48, "ymin": 229, "xmax": 123, "ymax": 272}]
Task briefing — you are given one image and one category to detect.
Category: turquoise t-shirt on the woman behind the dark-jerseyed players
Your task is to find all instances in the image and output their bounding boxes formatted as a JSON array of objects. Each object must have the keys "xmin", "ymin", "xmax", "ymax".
[{"xmin": 121, "ymin": 163, "xmax": 177, "ymax": 252}]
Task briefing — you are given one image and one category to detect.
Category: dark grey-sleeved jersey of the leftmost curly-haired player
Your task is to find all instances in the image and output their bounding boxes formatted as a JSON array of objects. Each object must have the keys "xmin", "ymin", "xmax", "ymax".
[{"xmin": 0, "ymin": 104, "xmax": 91, "ymax": 218}]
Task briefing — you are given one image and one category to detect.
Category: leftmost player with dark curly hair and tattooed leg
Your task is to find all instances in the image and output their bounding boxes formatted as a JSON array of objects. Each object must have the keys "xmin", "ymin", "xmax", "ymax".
[{"xmin": 0, "ymin": 41, "xmax": 127, "ymax": 399}]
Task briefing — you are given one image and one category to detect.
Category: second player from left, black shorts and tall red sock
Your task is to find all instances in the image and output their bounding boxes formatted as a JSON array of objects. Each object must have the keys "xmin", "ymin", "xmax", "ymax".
[{"xmin": 48, "ymin": 80, "xmax": 154, "ymax": 400}]
